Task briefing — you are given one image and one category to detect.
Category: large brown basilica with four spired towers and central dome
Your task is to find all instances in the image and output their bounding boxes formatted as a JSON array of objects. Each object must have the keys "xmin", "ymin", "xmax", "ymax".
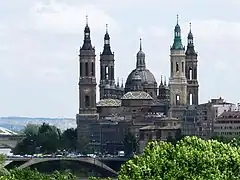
[{"xmin": 76, "ymin": 18, "xmax": 199, "ymax": 153}]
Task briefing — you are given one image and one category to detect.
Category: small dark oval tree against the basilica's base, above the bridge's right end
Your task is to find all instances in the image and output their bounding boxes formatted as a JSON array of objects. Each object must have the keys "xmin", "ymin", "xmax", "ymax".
[{"xmin": 124, "ymin": 132, "xmax": 137, "ymax": 156}]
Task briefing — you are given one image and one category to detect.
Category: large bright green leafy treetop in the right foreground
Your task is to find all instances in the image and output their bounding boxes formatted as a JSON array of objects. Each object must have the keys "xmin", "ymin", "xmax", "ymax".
[{"xmin": 118, "ymin": 137, "xmax": 240, "ymax": 180}]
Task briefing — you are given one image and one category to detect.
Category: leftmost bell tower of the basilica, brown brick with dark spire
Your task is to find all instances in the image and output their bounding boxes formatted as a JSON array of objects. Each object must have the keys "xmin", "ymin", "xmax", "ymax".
[{"xmin": 77, "ymin": 15, "xmax": 97, "ymax": 122}]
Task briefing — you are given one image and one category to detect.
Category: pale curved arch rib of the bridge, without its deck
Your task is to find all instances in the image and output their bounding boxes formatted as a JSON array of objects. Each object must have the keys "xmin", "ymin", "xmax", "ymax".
[{"xmin": 18, "ymin": 157, "xmax": 117, "ymax": 176}]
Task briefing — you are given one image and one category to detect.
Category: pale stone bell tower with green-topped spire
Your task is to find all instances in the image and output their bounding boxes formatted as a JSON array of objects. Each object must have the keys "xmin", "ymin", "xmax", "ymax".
[{"xmin": 169, "ymin": 16, "xmax": 187, "ymax": 106}]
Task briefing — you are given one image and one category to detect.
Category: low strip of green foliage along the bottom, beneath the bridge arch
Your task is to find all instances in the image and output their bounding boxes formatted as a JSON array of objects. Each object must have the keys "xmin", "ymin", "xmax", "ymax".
[{"xmin": 0, "ymin": 169, "xmax": 76, "ymax": 180}]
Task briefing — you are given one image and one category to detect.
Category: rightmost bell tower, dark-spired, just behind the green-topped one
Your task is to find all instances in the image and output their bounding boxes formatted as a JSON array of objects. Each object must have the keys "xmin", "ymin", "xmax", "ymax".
[{"xmin": 185, "ymin": 23, "xmax": 199, "ymax": 105}]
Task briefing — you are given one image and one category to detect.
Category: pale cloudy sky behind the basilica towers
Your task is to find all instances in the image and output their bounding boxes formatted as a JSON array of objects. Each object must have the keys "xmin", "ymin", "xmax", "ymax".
[{"xmin": 0, "ymin": 0, "xmax": 240, "ymax": 117}]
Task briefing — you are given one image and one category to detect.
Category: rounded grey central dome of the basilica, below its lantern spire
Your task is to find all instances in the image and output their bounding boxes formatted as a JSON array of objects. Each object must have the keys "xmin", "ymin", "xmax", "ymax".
[{"xmin": 125, "ymin": 68, "xmax": 157, "ymax": 87}]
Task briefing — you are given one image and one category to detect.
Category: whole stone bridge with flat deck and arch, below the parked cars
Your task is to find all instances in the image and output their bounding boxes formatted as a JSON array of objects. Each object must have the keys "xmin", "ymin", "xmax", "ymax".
[{"xmin": 5, "ymin": 157, "xmax": 129, "ymax": 176}]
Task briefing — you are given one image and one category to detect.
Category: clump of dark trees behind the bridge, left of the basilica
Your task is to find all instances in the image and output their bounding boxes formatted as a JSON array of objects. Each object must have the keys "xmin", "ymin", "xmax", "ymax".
[{"xmin": 13, "ymin": 123, "xmax": 78, "ymax": 155}]
